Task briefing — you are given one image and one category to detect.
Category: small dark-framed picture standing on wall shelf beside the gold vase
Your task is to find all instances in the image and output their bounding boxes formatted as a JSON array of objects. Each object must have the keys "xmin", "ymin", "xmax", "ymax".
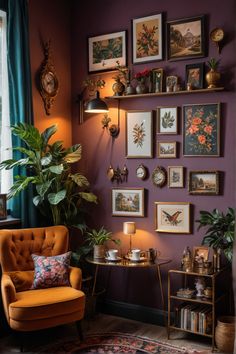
[{"xmin": 185, "ymin": 63, "xmax": 204, "ymax": 90}]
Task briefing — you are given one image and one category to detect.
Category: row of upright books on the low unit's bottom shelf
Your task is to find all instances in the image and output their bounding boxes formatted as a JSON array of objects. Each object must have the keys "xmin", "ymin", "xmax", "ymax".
[{"xmin": 175, "ymin": 303, "xmax": 212, "ymax": 334}]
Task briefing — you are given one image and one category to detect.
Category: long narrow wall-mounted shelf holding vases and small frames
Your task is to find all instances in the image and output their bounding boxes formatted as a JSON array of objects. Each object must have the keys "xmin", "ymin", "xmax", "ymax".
[{"xmin": 105, "ymin": 87, "xmax": 224, "ymax": 100}]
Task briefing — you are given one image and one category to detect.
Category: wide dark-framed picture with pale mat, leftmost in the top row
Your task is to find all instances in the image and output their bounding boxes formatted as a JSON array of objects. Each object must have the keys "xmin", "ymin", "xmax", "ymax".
[{"xmin": 88, "ymin": 31, "xmax": 127, "ymax": 73}]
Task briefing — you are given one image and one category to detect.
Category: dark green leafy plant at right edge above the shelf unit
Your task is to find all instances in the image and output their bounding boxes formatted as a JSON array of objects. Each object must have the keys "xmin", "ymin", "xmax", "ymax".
[{"xmin": 196, "ymin": 208, "xmax": 235, "ymax": 262}]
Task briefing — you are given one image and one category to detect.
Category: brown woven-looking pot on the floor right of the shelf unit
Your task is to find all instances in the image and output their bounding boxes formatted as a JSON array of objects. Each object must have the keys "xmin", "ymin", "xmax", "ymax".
[{"xmin": 215, "ymin": 316, "xmax": 236, "ymax": 353}]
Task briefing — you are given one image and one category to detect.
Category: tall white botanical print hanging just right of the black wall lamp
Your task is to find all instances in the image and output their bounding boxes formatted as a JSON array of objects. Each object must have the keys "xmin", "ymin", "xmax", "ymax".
[{"xmin": 126, "ymin": 111, "xmax": 153, "ymax": 158}]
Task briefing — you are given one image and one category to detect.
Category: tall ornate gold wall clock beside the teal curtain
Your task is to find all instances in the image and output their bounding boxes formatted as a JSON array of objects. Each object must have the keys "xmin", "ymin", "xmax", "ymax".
[{"xmin": 39, "ymin": 40, "xmax": 59, "ymax": 115}]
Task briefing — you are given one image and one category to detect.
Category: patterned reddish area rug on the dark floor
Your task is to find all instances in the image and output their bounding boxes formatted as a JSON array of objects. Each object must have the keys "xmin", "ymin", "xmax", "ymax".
[{"xmin": 37, "ymin": 332, "xmax": 205, "ymax": 354}]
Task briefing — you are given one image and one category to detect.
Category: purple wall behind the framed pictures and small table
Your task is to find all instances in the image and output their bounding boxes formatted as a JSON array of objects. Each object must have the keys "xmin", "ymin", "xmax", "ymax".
[{"xmin": 72, "ymin": 0, "xmax": 236, "ymax": 307}]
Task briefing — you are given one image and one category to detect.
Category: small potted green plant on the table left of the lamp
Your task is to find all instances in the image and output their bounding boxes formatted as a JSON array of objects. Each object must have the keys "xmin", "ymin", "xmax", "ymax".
[{"xmin": 87, "ymin": 226, "xmax": 120, "ymax": 258}]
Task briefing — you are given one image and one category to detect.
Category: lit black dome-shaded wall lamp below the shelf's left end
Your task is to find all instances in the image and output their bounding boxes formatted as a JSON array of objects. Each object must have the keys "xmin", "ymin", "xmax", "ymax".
[{"xmin": 76, "ymin": 89, "xmax": 109, "ymax": 124}]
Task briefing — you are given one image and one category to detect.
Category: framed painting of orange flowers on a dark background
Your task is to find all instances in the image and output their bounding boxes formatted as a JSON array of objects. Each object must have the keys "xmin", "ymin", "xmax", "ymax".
[{"xmin": 183, "ymin": 103, "xmax": 220, "ymax": 156}]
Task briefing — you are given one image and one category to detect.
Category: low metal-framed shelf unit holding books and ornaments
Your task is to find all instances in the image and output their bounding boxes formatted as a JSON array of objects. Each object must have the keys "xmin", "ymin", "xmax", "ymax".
[{"xmin": 168, "ymin": 268, "xmax": 230, "ymax": 350}]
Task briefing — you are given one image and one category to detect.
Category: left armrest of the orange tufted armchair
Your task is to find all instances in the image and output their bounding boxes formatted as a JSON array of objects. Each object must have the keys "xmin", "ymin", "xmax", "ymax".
[{"xmin": 1, "ymin": 273, "xmax": 16, "ymax": 323}]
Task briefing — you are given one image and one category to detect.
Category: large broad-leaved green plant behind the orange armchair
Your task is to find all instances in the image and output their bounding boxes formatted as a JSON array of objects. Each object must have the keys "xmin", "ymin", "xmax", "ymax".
[{"xmin": 0, "ymin": 123, "xmax": 97, "ymax": 226}]
